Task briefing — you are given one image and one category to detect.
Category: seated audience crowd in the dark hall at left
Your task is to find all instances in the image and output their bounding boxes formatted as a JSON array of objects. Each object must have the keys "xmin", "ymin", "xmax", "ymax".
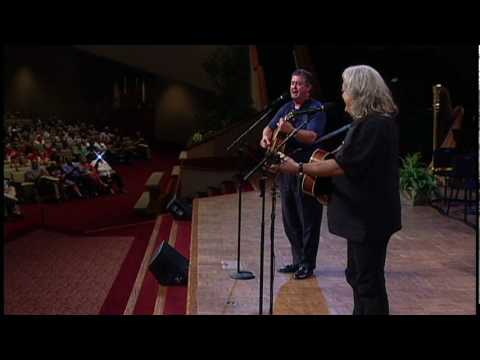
[{"xmin": 4, "ymin": 119, "xmax": 150, "ymax": 216}]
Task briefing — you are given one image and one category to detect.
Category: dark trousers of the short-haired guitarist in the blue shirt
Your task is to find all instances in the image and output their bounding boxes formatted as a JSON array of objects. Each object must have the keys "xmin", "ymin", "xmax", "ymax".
[{"xmin": 279, "ymin": 174, "xmax": 323, "ymax": 268}]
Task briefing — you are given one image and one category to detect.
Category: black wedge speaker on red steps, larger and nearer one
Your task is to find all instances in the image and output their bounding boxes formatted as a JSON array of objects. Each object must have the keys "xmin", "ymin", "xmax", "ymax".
[{"xmin": 149, "ymin": 241, "xmax": 188, "ymax": 285}]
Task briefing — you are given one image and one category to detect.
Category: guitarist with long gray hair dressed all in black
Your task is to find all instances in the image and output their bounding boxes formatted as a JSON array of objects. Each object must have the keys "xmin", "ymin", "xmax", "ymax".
[{"xmin": 273, "ymin": 65, "xmax": 401, "ymax": 315}]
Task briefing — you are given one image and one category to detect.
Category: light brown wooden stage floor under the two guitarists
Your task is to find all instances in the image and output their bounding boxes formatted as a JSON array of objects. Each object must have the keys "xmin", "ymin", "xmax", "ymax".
[{"xmin": 187, "ymin": 192, "xmax": 477, "ymax": 315}]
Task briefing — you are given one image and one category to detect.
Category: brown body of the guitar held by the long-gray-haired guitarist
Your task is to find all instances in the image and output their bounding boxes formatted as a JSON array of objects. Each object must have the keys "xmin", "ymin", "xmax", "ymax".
[{"xmin": 302, "ymin": 149, "xmax": 333, "ymax": 205}]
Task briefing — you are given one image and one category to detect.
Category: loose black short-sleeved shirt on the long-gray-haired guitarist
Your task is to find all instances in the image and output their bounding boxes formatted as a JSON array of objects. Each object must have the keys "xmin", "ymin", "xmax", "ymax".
[{"xmin": 328, "ymin": 115, "xmax": 401, "ymax": 242}]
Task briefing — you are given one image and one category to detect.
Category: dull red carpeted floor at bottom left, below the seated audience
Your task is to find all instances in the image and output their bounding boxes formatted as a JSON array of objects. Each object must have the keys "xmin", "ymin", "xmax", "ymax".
[{"xmin": 5, "ymin": 230, "xmax": 133, "ymax": 315}]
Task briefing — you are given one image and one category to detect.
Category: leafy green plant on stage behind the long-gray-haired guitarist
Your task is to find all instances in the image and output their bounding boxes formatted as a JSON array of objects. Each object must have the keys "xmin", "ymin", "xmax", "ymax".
[{"xmin": 400, "ymin": 152, "xmax": 438, "ymax": 206}]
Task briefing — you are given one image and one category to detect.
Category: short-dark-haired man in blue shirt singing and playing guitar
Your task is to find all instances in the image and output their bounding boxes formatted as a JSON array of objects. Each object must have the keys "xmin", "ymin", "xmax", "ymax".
[{"xmin": 260, "ymin": 69, "xmax": 327, "ymax": 279}]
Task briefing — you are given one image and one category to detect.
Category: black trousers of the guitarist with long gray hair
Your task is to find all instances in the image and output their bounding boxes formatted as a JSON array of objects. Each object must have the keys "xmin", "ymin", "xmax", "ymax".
[{"xmin": 345, "ymin": 238, "xmax": 389, "ymax": 315}]
